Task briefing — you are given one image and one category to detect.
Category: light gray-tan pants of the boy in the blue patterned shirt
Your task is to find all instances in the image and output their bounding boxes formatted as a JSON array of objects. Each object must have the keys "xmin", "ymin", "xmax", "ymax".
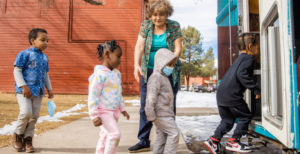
[{"xmin": 15, "ymin": 94, "xmax": 43, "ymax": 138}]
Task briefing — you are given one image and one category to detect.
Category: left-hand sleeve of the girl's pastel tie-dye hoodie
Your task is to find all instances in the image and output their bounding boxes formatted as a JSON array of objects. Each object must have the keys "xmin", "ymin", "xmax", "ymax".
[{"xmin": 88, "ymin": 73, "xmax": 104, "ymax": 120}]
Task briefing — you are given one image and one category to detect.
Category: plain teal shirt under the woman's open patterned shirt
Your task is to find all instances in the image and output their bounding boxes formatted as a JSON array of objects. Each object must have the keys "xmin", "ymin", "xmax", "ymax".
[{"xmin": 148, "ymin": 31, "xmax": 168, "ymax": 69}]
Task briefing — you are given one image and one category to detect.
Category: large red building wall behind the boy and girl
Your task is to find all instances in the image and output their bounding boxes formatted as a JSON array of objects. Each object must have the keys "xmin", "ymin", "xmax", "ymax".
[{"xmin": 0, "ymin": 0, "xmax": 144, "ymax": 94}]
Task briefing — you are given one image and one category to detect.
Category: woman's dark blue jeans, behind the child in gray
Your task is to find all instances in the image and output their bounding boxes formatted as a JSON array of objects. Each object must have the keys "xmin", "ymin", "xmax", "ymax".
[{"xmin": 138, "ymin": 69, "xmax": 178, "ymax": 146}]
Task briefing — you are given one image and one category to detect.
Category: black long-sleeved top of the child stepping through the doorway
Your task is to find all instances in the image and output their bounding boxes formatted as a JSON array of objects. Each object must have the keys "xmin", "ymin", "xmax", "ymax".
[{"xmin": 217, "ymin": 53, "xmax": 260, "ymax": 106}]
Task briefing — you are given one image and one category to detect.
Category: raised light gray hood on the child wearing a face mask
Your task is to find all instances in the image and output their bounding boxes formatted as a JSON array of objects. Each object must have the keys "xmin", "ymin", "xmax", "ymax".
[{"xmin": 154, "ymin": 48, "xmax": 176, "ymax": 72}]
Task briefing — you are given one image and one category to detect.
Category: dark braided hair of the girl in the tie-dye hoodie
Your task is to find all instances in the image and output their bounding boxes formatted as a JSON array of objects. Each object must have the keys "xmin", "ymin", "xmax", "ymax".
[{"xmin": 96, "ymin": 40, "xmax": 122, "ymax": 60}]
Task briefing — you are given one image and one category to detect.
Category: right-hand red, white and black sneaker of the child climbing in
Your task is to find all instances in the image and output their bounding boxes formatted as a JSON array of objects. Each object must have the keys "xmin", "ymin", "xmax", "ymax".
[{"xmin": 226, "ymin": 138, "xmax": 252, "ymax": 153}]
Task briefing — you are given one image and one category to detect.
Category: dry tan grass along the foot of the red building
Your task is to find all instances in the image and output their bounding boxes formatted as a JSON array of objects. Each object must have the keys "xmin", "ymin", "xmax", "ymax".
[{"xmin": 0, "ymin": 93, "xmax": 139, "ymax": 147}]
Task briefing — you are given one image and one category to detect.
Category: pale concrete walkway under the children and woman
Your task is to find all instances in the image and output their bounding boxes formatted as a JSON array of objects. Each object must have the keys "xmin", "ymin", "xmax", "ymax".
[{"xmin": 0, "ymin": 107, "xmax": 217, "ymax": 154}]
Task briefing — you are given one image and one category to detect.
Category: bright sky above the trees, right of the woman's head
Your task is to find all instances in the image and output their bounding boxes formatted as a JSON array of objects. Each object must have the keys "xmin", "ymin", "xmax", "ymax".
[{"xmin": 169, "ymin": 0, "xmax": 218, "ymax": 60}]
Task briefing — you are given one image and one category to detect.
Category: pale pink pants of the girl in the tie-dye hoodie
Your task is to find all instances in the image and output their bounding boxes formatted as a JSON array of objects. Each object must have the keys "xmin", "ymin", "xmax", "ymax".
[{"xmin": 96, "ymin": 109, "xmax": 121, "ymax": 154}]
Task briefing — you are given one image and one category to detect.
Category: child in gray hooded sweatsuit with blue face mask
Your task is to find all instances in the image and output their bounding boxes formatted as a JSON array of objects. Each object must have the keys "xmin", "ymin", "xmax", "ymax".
[{"xmin": 145, "ymin": 49, "xmax": 179, "ymax": 154}]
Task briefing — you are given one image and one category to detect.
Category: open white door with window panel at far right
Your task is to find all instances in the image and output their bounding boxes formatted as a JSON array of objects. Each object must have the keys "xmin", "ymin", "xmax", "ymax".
[{"xmin": 259, "ymin": 0, "xmax": 291, "ymax": 147}]
